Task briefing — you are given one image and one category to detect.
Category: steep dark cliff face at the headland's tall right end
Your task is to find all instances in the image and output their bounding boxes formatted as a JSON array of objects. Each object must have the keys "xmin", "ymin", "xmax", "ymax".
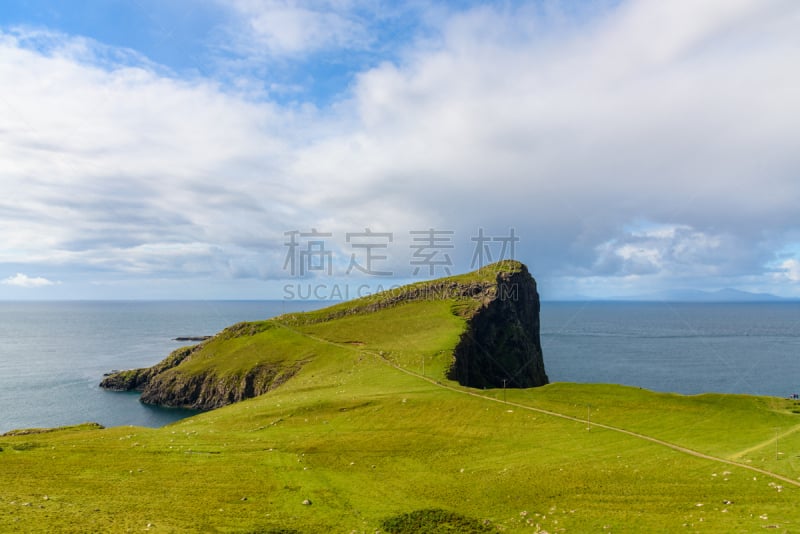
[{"xmin": 448, "ymin": 266, "xmax": 548, "ymax": 388}]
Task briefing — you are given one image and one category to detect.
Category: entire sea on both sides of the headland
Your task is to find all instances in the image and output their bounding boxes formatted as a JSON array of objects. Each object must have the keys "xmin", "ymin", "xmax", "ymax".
[{"xmin": 0, "ymin": 300, "xmax": 800, "ymax": 433}]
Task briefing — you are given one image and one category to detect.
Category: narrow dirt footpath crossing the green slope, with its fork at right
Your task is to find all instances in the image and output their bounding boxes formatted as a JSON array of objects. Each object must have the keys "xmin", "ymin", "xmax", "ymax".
[{"xmin": 281, "ymin": 324, "xmax": 800, "ymax": 494}]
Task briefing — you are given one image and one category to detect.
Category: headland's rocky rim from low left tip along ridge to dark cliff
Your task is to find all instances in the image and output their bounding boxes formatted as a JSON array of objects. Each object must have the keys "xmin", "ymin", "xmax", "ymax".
[{"xmin": 100, "ymin": 261, "xmax": 547, "ymax": 410}]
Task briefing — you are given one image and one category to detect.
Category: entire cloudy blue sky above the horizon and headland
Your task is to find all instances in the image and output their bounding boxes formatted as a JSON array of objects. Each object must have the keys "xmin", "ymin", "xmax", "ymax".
[{"xmin": 0, "ymin": 0, "xmax": 800, "ymax": 300}]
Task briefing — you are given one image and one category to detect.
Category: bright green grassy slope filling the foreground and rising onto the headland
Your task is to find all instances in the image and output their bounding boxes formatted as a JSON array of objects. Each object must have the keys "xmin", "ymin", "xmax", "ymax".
[{"xmin": 0, "ymin": 264, "xmax": 800, "ymax": 533}]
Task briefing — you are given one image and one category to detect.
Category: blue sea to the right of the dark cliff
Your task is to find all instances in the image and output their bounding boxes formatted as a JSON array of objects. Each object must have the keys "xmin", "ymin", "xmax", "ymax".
[{"xmin": 541, "ymin": 302, "xmax": 800, "ymax": 397}]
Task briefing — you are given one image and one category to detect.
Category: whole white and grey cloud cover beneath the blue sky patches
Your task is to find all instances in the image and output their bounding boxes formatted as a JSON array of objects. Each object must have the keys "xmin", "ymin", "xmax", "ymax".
[{"xmin": 0, "ymin": 0, "xmax": 800, "ymax": 298}]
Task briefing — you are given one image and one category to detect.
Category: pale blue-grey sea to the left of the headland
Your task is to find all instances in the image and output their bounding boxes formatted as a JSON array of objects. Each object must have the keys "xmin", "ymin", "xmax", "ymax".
[{"xmin": 0, "ymin": 301, "xmax": 320, "ymax": 433}]
